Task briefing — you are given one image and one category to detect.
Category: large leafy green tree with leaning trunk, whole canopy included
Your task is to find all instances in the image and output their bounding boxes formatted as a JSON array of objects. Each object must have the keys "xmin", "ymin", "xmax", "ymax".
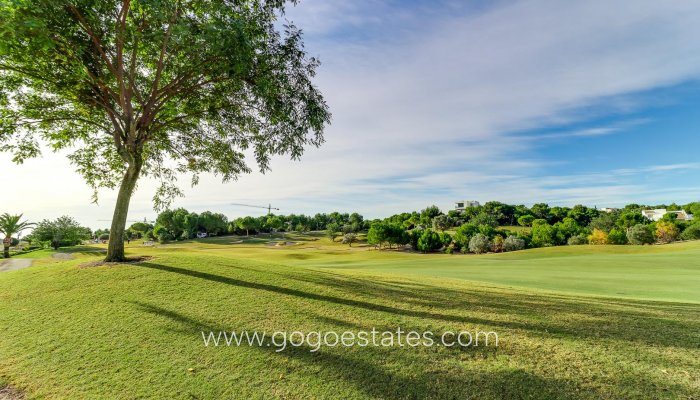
[{"xmin": 0, "ymin": 0, "xmax": 330, "ymax": 261}]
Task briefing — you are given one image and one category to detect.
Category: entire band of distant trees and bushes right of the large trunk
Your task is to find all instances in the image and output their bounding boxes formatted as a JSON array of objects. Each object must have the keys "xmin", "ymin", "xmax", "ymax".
[{"xmin": 108, "ymin": 201, "xmax": 700, "ymax": 253}]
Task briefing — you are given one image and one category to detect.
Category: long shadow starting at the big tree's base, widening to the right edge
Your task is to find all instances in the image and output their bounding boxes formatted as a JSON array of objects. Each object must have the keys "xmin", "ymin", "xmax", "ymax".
[{"xmin": 138, "ymin": 262, "xmax": 700, "ymax": 350}]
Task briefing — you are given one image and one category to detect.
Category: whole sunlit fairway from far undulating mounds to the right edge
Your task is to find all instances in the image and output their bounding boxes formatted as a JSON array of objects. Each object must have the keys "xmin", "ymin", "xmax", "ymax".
[{"xmin": 173, "ymin": 235, "xmax": 700, "ymax": 303}]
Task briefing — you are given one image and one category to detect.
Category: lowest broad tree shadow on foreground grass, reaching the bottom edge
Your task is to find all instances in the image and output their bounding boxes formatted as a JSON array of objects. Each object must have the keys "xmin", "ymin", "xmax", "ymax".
[{"xmin": 133, "ymin": 302, "xmax": 692, "ymax": 400}]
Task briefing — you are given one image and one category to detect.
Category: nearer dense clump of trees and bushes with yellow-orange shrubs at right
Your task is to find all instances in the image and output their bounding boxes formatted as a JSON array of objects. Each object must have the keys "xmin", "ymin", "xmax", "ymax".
[{"xmin": 360, "ymin": 201, "xmax": 700, "ymax": 253}]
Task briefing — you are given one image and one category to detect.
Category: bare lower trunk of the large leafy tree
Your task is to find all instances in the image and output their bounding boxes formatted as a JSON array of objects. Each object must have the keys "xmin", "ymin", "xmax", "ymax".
[{"xmin": 105, "ymin": 163, "xmax": 141, "ymax": 262}]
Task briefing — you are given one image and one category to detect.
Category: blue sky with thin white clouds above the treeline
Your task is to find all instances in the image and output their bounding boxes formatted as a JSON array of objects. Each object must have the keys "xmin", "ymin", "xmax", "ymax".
[{"xmin": 0, "ymin": 0, "xmax": 700, "ymax": 226}]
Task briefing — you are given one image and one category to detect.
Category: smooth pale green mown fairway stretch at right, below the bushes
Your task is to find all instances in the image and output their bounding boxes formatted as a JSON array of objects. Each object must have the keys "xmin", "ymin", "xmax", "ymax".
[{"xmin": 288, "ymin": 243, "xmax": 700, "ymax": 303}]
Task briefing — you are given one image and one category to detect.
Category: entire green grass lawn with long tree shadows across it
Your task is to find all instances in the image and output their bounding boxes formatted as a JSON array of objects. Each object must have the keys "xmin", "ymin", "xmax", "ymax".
[{"xmin": 0, "ymin": 235, "xmax": 700, "ymax": 399}]
